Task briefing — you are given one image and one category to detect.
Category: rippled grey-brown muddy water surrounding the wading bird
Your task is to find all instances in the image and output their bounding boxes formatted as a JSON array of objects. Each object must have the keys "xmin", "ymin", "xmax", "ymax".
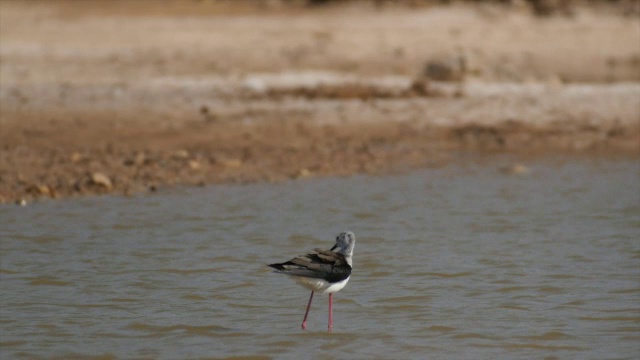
[{"xmin": 0, "ymin": 158, "xmax": 640, "ymax": 359}]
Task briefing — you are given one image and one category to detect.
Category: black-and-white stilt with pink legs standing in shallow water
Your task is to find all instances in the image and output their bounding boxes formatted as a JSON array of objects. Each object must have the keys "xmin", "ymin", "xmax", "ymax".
[{"xmin": 268, "ymin": 231, "xmax": 356, "ymax": 331}]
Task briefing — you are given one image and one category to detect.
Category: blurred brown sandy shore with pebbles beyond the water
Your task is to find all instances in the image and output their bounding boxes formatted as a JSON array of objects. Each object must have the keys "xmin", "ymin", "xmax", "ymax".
[{"xmin": 0, "ymin": 1, "xmax": 640, "ymax": 202}]
